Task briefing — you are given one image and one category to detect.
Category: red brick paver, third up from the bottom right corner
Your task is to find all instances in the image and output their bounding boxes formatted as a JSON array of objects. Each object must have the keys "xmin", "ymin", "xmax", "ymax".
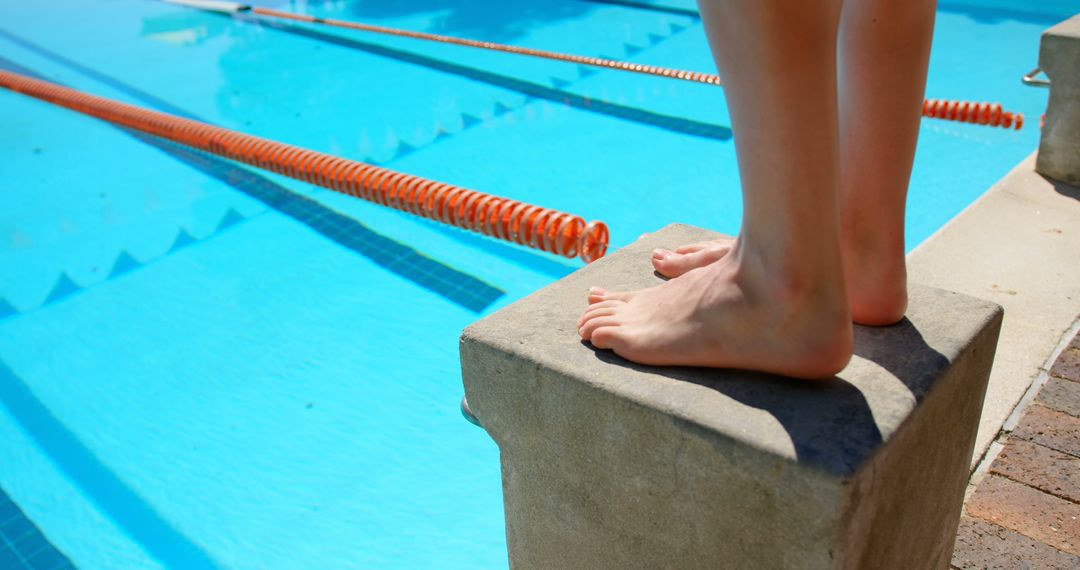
[{"xmin": 990, "ymin": 438, "xmax": 1080, "ymax": 503}]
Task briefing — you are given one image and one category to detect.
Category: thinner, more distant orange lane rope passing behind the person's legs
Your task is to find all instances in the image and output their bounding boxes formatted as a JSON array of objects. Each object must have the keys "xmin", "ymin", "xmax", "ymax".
[{"xmin": 165, "ymin": 0, "xmax": 1024, "ymax": 130}]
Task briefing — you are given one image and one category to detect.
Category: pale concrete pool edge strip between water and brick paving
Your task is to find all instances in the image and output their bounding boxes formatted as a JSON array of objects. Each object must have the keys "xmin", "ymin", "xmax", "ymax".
[{"xmin": 908, "ymin": 152, "xmax": 1080, "ymax": 467}]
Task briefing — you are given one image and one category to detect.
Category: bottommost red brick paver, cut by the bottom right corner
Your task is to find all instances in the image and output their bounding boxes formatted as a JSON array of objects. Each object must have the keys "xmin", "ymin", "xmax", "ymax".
[{"xmin": 953, "ymin": 516, "xmax": 1080, "ymax": 570}]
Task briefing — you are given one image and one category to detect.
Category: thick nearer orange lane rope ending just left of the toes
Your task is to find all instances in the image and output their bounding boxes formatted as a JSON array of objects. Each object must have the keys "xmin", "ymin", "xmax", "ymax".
[{"xmin": 0, "ymin": 70, "xmax": 608, "ymax": 262}]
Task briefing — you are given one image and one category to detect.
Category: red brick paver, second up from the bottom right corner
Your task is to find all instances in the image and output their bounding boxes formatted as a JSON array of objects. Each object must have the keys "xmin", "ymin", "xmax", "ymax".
[{"xmin": 967, "ymin": 475, "xmax": 1080, "ymax": 556}]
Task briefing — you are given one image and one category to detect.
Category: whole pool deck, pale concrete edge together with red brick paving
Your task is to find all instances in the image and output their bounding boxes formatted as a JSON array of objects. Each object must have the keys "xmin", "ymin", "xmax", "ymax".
[{"xmin": 908, "ymin": 154, "xmax": 1080, "ymax": 570}]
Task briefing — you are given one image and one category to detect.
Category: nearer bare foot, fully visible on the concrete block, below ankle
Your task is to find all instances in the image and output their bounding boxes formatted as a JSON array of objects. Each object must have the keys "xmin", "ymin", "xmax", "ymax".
[{"xmin": 578, "ymin": 249, "xmax": 852, "ymax": 378}]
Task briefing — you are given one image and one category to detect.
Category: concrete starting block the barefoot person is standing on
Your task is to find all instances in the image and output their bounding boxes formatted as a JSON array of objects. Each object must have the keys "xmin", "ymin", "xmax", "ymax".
[{"xmin": 461, "ymin": 226, "xmax": 1001, "ymax": 569}]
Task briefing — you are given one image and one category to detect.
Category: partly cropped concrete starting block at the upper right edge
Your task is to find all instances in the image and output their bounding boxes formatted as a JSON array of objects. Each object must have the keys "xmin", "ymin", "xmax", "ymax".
[{"xmin": 1036, "ymin": 14, "xmax": 1080, "ymax": 186}]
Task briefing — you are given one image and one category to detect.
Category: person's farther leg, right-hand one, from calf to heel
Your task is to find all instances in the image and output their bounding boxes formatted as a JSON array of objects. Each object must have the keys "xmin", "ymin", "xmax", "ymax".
[{"xmin": 839, "ymin": 0, "xmax": 934, "ymax": 325}]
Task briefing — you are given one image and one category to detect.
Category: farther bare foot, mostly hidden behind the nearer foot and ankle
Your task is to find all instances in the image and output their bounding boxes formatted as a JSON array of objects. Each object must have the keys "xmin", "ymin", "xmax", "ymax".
[{"xmin": 643, "ymin": 235, "xmax": 907, "ymax": 326}]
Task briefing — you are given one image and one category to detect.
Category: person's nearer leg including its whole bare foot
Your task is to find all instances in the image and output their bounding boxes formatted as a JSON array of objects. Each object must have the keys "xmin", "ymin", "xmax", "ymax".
[{"xmin": 579, "ymin": 0, "xmax": 851, "ymax": 377}]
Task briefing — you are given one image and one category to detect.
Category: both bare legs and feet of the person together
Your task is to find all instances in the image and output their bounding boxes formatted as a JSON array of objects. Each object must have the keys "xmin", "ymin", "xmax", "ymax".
[{"xmin": 579, "ymin": 0, "xmax": 934, "ymax": 378}]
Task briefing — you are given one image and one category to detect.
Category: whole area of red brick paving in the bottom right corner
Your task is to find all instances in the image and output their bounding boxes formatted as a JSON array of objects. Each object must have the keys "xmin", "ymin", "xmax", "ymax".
[{"xmin": 951, "ymin": 328, "xmax": 1080, "ymax": 570}]
